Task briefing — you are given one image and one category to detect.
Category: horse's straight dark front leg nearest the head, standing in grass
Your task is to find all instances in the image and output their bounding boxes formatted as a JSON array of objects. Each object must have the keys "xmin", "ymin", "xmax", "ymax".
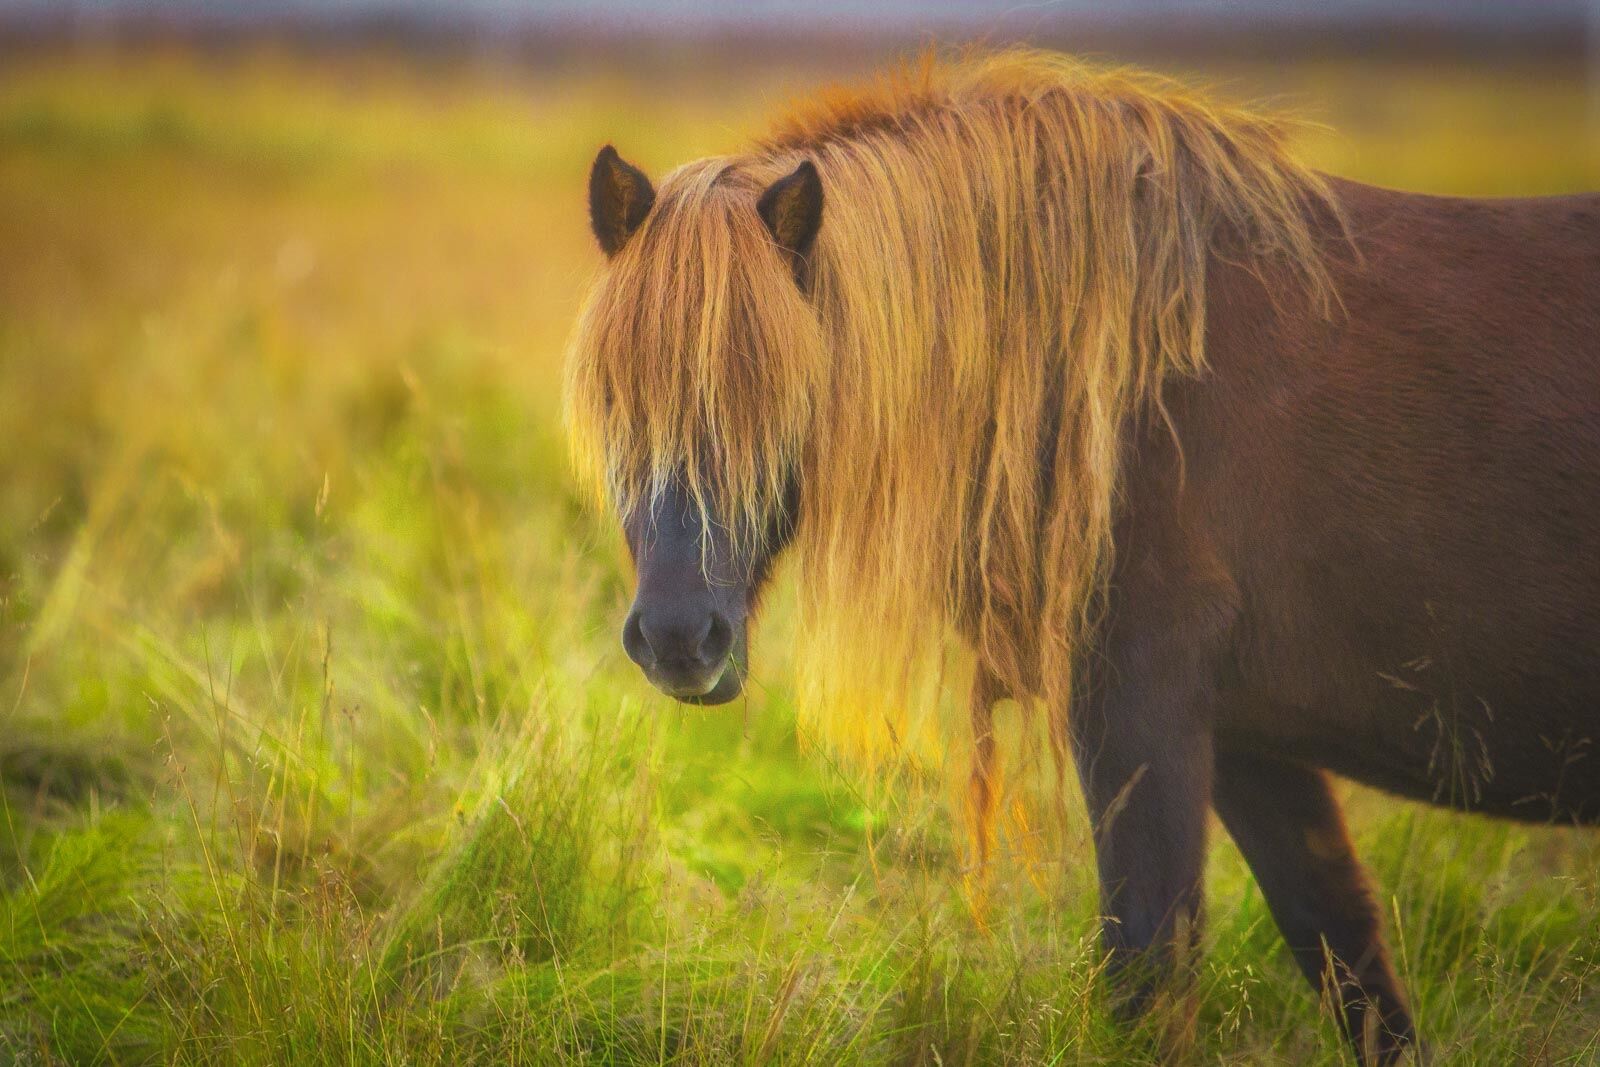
[{"xmin": 1072, "ymin": 640, "xmax": 1214, "ymax": 1036}]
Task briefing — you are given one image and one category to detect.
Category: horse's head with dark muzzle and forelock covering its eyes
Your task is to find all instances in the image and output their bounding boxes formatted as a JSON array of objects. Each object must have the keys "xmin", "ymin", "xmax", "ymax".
[{"xmin": 568, "ymin": 147, "xmax": 822, "ymax": 704}]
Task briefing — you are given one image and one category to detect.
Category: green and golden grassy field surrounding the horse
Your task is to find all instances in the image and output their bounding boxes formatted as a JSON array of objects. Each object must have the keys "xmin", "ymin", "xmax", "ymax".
[{"xmin": 0, "ymin": 39, "xmax": 1600, "ymax": 1064}]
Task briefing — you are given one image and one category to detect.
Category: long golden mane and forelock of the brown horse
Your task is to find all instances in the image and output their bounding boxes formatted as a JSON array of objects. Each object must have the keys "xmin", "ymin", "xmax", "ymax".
[{"xmin": 568, "ymin": 51, "xmax": 1333, "ymax": 799}]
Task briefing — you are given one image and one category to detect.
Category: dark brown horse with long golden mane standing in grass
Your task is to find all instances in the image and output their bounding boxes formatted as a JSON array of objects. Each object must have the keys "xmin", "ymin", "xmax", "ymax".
[{"xmin": 570, "ymin": 53, "xmax": 1600, "ymax": 1062}]
